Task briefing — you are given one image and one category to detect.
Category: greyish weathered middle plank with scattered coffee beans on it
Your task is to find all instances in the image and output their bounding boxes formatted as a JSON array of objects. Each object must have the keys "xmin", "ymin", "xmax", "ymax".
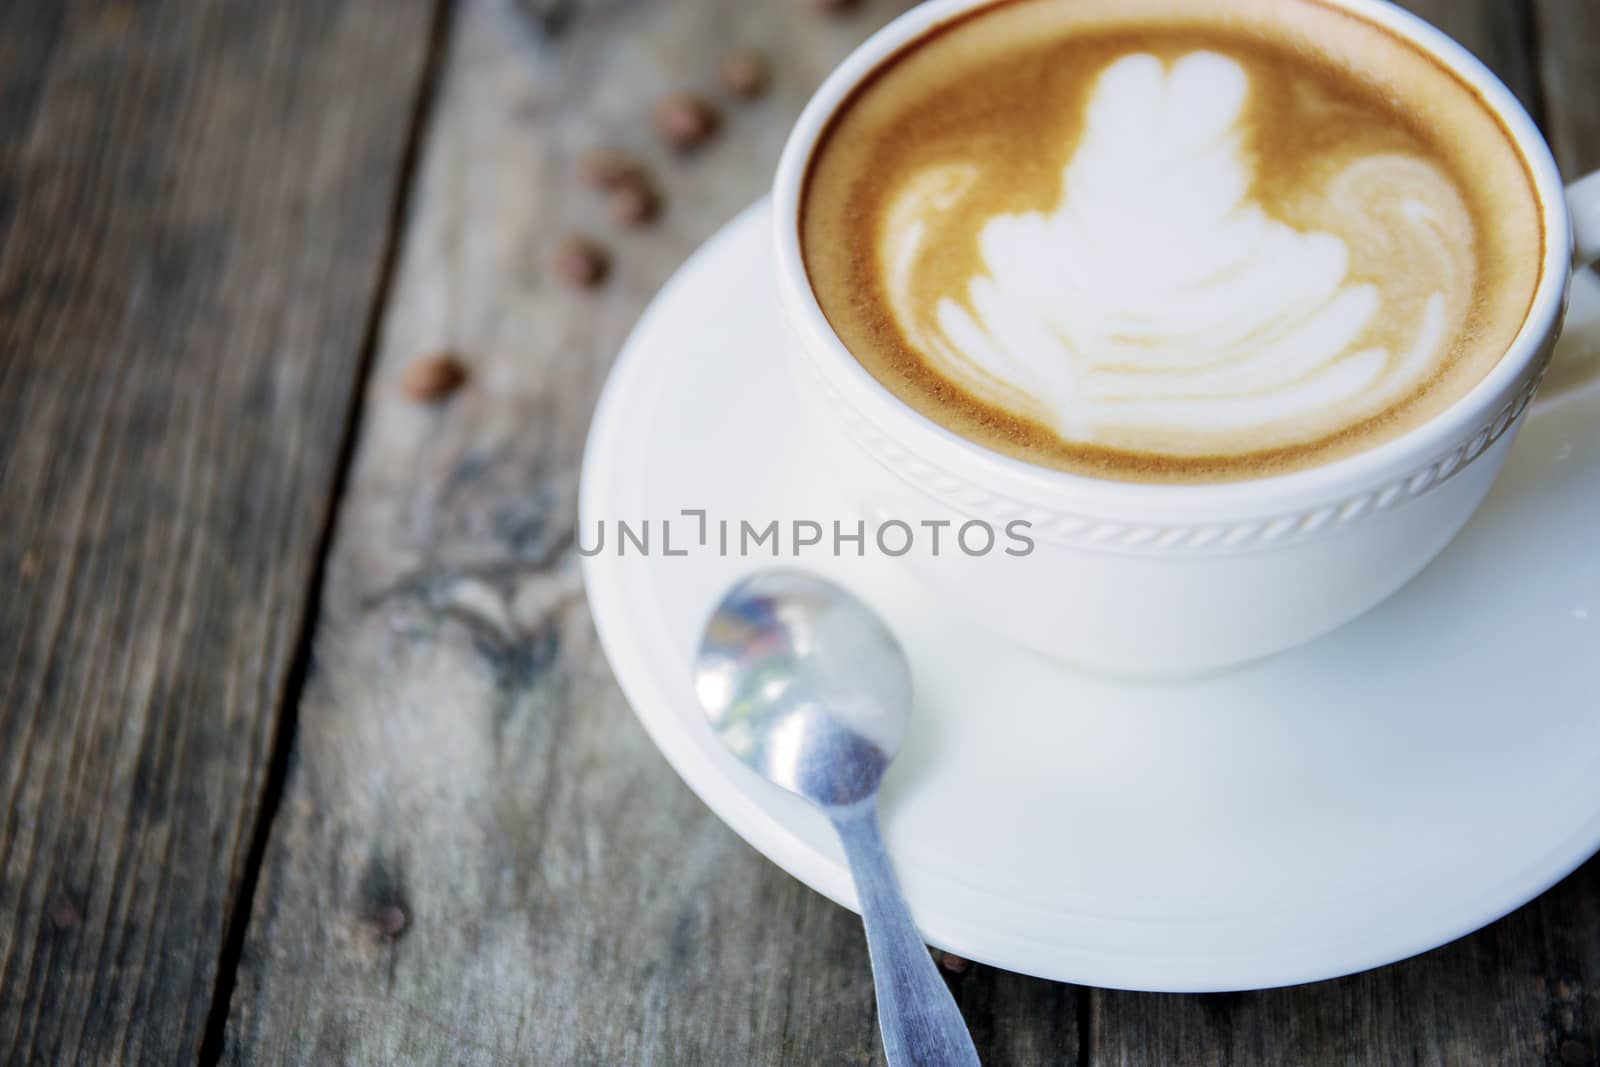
[{"xmin": 227, "ymin": 0, "xmax": 1077, "ymax": 1065}]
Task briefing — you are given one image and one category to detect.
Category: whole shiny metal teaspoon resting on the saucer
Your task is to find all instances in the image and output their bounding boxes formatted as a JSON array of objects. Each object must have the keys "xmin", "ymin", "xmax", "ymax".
[{"xmin": 694, "ymin": 571, "xmax": 978, "ymax": 1067}]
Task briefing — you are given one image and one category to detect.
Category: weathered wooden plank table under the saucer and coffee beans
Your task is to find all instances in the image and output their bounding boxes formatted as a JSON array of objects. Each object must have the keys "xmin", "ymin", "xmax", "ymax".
[{"xmin": 0, "ymin": 0, "xmax": 1600, "ymax": 1065}]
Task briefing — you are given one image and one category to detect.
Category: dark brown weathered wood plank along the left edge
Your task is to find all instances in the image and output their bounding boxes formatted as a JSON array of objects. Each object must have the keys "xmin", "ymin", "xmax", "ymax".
[{"xmin": 0, "ymin": 0, "xmax": 430, "ymax": 1064}]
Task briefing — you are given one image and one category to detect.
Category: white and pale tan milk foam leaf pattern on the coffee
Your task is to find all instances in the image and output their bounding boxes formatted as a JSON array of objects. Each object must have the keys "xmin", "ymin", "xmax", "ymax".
[{"xmin": 877, "ymin": 51, "xmax": 1477, "ymax": 456}]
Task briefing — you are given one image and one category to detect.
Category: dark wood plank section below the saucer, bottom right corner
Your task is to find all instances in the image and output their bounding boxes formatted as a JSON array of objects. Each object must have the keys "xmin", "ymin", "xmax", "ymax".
[{"xmin": 1088, "ymin": 861, "xmax": 1600, "ymax": 1067}]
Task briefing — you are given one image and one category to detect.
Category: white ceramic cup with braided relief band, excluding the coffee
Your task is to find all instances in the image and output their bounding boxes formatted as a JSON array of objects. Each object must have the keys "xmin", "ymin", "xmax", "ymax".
[{"xmin": 773, "ymin": 0, "xmax": 1600, "ymax": 675}]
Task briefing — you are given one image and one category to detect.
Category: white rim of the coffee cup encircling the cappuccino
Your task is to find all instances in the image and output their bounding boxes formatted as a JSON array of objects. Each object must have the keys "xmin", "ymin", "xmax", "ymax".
[{"xmin": 773, "ymin": 0, "xmax": 1573, "ymax": 512}]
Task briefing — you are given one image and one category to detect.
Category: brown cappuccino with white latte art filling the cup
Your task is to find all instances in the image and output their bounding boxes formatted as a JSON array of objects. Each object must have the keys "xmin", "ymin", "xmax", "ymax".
[{"xmin": 800, "ymin": 0, "xmax": 1544, "ymax": 482}]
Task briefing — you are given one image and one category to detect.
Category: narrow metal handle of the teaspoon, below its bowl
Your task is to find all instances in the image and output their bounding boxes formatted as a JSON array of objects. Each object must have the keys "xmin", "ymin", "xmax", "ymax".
[{"xmin": 827, "ymin": 797, "xmax": 979, "ymax": 1067}]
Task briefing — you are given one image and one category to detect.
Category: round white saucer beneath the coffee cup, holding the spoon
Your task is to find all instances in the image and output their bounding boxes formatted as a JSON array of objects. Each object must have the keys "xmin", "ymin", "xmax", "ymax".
[{"xmin": 579, "ymin": 202, "xmax": 1600, "ymax": 990}]
